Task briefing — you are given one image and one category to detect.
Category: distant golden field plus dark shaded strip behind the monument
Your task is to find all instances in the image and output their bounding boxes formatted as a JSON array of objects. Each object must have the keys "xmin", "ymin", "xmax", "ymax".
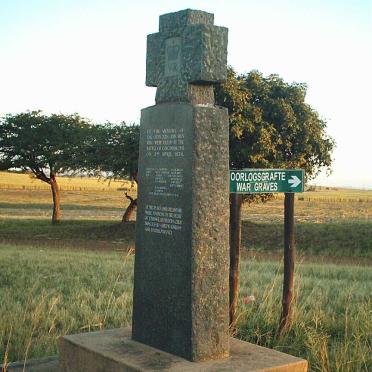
[{"xmin": 0, "ymin": 172, "xmax": 372, "ymax": 262}]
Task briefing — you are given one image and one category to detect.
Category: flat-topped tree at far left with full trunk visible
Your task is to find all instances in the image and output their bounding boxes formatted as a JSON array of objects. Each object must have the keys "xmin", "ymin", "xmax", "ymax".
[{"xmin": 0, "ymin": 111, "xmax": 89, "ymax": 223}]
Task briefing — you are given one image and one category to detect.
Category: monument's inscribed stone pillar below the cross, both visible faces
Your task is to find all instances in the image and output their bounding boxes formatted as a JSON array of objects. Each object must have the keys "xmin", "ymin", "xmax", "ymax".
[{"xmin": 133, "ymin": 103, "xmax": 229, "ymax": 360}]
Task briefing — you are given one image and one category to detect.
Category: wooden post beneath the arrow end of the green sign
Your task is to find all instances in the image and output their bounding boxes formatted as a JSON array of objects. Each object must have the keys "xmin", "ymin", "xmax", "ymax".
[{"xmin": 279, "ymin": 192, "xmax": 296, "ymax": 332}]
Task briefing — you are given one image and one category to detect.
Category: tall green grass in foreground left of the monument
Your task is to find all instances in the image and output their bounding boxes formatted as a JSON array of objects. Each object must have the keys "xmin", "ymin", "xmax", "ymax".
[{"xmin": 0, "ymin": 245, "xmax": 133, "ymax": 363}]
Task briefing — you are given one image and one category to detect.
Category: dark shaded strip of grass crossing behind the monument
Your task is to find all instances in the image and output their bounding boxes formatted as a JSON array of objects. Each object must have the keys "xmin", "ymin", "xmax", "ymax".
[{"xmin": 0, "ymin": 219, "xmax": 372, "ymax": 259}]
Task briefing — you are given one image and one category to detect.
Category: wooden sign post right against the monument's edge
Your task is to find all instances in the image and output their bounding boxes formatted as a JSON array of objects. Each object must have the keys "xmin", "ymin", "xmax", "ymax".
[{"xmin": 229, "ymin": 194, "xmax": 243, "ymax": 333}]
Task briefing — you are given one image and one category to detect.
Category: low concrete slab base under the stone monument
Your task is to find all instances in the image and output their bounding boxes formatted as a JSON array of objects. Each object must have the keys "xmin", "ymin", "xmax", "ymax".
[{"xmin": 59, "ymin": 328, "xmax": 307, "ymax": 372}]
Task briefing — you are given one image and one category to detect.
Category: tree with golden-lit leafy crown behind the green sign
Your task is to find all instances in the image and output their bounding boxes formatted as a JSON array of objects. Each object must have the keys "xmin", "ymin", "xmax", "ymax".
[{"xmin": 215, "ymin": 68, "xmax": 334, "ymax": 332}]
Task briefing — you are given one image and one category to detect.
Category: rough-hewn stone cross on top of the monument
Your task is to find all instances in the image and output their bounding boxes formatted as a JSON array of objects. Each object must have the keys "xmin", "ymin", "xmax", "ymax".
[{"xmin": 146, "ymin": 9, "xmax": 228, "ymax": 104}]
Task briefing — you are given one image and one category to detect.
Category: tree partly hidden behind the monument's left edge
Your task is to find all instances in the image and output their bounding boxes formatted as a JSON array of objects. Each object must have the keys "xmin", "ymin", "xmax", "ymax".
[{"xmin": 86, "ymin": 122, "xmax": 139, "ymax": 222}]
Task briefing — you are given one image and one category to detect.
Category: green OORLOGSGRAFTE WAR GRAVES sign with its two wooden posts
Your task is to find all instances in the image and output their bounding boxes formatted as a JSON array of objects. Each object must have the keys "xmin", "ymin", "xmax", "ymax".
[{"xmin": 230, "ymin": 169, "xmax": 305, "ymax": 331}]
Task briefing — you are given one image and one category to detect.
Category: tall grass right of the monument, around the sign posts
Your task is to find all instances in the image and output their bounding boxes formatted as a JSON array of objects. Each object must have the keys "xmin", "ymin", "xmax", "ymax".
[{"xmin": 238, "ymin": 261, "xmax": 372, "ymax": 371}]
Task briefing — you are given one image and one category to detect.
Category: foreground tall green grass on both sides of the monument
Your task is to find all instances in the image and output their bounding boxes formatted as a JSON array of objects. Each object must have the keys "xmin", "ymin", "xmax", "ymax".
[{"xmin": 0, "ymin": 244, "xmax": 372, "ymax": 371}]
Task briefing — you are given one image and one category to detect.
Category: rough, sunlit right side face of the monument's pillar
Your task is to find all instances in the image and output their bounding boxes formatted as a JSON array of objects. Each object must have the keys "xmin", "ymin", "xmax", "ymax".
[{"xmin": 191, "ymin": 105, "xmax": 229, "ymax": 360}]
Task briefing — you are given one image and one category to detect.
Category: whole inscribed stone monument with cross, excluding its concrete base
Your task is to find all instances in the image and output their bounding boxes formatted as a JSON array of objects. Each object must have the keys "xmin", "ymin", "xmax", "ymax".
[{"xmin": 132, "ymin": 9, "xmax": 229, "ymax": 361}]
